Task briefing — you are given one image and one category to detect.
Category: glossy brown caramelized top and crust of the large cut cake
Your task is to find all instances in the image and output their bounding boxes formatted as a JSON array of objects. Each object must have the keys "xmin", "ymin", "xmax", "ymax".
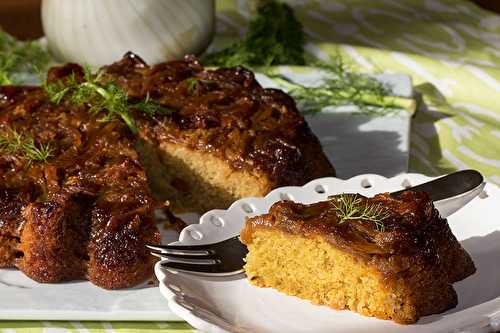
[{"xmin": 0, "ymin": 54, "xmax": 334, "ymax": 288}]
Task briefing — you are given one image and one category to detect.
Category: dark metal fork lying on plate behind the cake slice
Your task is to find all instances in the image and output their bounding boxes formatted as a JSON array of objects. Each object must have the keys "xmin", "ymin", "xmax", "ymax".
[{"xmin": 146, "ymin": 170, "xmax": 485, "ymax": 276}]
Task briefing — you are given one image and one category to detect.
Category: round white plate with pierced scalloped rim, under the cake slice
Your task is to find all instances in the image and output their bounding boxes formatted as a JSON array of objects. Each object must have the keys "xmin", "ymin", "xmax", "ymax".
[{"xmin": 155, "ymin": 174, "xmax": 500, "ymax": 333}]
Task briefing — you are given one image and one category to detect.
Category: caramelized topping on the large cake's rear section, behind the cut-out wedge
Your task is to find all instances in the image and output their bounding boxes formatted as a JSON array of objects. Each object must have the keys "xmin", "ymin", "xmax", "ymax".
[{"xmin": 102, "ymin": 54, "xmax": 333, "ymax": 185}]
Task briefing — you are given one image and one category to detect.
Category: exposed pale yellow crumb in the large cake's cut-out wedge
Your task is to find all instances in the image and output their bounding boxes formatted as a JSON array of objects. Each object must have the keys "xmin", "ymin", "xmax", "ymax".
[{"xmin": 138, "ymin": 141, "xmax": 274, "ymax": 213}]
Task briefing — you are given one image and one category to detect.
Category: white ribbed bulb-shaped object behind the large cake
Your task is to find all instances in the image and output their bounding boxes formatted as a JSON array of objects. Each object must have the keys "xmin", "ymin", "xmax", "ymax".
[{"xmin": 42, "ymin": 0, "xmax": 215, "ymax": 67}]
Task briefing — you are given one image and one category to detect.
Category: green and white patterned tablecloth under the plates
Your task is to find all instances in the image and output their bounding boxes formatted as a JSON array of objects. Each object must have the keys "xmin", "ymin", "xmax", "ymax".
[{"xmin": 0, "ymin": 0, "xmax": 500, "ymax": 333}]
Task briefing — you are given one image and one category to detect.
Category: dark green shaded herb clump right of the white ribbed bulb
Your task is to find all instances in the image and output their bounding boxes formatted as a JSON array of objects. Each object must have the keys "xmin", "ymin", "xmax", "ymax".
[{"xmin": 202, "ymin": 0, "xmax": 305, "ymax": 67}]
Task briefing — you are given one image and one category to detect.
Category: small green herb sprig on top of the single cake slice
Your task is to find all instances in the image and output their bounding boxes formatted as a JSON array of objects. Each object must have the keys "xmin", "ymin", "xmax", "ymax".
[{"xmin": 331, "ymin": 194, "xmax": 390, "ymax": 231}]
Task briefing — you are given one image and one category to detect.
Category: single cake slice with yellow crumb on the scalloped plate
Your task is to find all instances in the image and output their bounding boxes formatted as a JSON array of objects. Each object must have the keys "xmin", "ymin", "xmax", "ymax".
[{"xmin": 241, "ymin": 192, "xmax": 475, "ymax": 324}]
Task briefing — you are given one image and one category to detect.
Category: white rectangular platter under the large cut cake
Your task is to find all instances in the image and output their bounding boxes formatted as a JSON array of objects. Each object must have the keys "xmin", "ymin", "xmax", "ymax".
[{"xmin": 0, "ymin": 67, "xmax": 412, "ymax": 321}]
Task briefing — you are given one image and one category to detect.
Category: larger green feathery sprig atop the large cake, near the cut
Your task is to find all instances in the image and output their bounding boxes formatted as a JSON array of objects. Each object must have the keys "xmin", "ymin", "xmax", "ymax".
[{"xmin": 44, "ymin": 67, "xmax": 173, "ymax": 134}]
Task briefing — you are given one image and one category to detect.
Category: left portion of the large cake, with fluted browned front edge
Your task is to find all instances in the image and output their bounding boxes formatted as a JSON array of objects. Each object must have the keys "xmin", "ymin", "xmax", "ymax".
[{"xmin": 0, "ymin": 81, "xmax": 160, "ymax": 289}]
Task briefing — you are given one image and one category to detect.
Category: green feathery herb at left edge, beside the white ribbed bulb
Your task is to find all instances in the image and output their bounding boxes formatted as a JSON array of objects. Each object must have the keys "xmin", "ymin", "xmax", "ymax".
[{"xmin": 0, "ymin": 30, "xmax": 49, "ymax": 85}]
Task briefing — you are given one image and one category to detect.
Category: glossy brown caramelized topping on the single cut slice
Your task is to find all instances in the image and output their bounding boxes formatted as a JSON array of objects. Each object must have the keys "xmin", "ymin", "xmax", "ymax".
[{"xmin": 241, "ymin": 191, "xmax": 447, "ymax": 270}]
